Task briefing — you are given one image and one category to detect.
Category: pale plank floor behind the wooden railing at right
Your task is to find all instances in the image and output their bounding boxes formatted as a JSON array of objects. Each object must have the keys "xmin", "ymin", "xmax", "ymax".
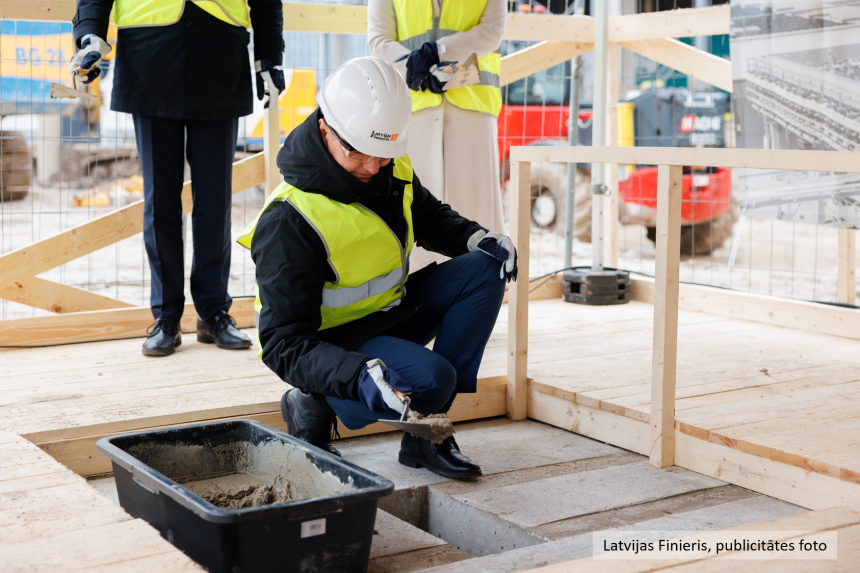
[{"xmin": 508, "ymin": 301, "xmax": 860, "ymax": 488}]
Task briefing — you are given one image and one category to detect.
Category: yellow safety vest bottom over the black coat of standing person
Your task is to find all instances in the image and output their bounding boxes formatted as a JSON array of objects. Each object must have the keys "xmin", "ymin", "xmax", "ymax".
[{"xmin": 114, "ymin": 0, "xmax": 251, "ymax": 28}]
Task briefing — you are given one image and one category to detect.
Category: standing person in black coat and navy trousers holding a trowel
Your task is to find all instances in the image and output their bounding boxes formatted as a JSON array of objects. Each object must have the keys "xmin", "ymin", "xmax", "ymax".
[{"xmin": 70, "ymin": 0, "xmax": 284, "ymax": 356}]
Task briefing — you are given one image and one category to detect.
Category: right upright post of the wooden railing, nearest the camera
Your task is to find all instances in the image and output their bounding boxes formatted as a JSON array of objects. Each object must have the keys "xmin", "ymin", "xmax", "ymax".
[{"xmin": 651, "ymin": 165, "xmax": 682, "ymax": 468}]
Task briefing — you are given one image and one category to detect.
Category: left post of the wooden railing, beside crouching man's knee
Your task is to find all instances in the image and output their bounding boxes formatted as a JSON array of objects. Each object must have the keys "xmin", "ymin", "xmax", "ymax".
[{"xmin": 507, "ymin": 162, "xmax": 532, "ymax": 420}]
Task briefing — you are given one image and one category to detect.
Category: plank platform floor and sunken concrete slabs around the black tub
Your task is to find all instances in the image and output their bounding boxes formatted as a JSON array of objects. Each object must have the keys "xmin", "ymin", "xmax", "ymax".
[{"xmin": 0, "ymin": 300, "xmax": 860, "ymax": 572}]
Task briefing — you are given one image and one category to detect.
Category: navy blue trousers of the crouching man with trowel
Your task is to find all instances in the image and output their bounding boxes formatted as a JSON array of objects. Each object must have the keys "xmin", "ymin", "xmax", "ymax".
[{"xmin": 326, "ymin": 253, "xmax": 506, "ymax": 430}]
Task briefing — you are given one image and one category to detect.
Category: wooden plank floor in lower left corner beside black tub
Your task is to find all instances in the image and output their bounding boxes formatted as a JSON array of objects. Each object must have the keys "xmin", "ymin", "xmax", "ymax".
[{"xmin": 0, "ymin": 432, "xmax": 202, "ymax": 572}]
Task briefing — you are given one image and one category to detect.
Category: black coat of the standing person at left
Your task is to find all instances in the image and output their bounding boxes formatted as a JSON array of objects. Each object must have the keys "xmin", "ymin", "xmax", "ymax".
[{"xmin": 75, "ymin": 0, "xmax": 284, "ymax": 120}]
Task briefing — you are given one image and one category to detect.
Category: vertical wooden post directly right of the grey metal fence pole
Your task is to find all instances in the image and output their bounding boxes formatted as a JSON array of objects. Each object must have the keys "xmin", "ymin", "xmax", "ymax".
[{"xmin": 603, "ymin": 44, "xmax": 621, "ymax": 268}]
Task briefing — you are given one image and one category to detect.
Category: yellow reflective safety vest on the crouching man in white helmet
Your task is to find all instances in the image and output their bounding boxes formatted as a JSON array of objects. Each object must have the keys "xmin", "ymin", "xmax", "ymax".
[{"xmin": 238, "ymin": 155, "xmax": 415, "ymax": 354}]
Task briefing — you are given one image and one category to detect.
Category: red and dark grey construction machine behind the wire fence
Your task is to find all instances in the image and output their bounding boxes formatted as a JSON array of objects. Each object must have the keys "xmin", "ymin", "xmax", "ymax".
[{"xmin": 498, "ymin": 62, "xmax": 737, "ymax": 255}]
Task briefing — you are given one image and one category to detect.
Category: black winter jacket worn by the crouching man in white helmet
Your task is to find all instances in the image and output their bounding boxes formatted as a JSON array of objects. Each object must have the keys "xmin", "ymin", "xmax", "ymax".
[{"xmin": 251, "ymin": 109, "xmax": 483, "ymax": 400}]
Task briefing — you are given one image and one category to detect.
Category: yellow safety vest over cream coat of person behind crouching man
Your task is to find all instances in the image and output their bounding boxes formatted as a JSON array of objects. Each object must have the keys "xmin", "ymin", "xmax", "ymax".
[{"xmin": 394, "ymin": 0, "xmax": 502, "ymax": 116}]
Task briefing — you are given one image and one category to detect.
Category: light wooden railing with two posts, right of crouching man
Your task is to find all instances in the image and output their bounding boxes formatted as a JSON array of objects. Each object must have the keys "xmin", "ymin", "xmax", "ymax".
[{"xmin": 508, "ymin": 143, "xmax": 860, "ymax": 492}]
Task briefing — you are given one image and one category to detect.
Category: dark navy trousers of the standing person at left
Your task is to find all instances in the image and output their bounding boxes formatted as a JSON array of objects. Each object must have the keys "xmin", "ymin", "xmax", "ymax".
[{"xmin": 133, "ymin": 115, "xmax": 239, "ymax": 320}]
